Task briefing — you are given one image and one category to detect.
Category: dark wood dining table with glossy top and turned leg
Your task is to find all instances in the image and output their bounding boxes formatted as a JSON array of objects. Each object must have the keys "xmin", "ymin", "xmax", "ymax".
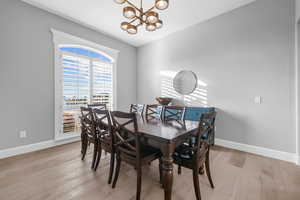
[{"xmin": 110, "ymin": 115, "xmax": 198, "ymax": 200}]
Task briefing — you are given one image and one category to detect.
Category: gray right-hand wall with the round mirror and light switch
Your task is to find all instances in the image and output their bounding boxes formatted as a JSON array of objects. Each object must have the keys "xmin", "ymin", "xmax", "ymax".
[{"xmin": 137, "ymin": 0, "xmax": 295, "ymax": 153}]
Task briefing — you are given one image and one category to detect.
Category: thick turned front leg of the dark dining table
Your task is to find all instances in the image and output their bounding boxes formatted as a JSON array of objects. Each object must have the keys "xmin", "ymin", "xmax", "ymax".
[{"xmin": 162, "ymin": 145, "xmax": 173, "ymax": 200}]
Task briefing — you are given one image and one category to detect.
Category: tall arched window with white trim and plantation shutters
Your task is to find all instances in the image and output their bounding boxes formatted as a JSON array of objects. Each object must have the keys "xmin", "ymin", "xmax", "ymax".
[{"xmin": 52, "ymin": 31, "xmax": 116, "ymax": 139}]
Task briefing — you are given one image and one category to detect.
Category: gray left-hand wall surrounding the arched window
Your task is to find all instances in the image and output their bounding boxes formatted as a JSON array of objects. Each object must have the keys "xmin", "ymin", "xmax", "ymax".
[{"xmin": 0, "ymin": 0, "xmax": 136, "ymax": 149}]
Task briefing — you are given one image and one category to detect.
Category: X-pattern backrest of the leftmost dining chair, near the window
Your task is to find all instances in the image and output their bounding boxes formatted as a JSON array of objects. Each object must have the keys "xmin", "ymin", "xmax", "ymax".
[{"xmin": 80, "ymin": 107, "xmax": 96, "ymax": 138}]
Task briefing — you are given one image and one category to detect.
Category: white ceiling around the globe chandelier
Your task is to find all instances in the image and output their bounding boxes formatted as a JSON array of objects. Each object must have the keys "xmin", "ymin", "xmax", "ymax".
[{"xmin": 23, "ymin": 0, "xmax": 255, "ymax": 46}]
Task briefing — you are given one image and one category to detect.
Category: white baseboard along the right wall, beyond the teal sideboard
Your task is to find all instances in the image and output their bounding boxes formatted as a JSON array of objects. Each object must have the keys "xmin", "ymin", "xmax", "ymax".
[{"xmin": 215, "ymin": 139, "xmax": 299, "ymax": 163}]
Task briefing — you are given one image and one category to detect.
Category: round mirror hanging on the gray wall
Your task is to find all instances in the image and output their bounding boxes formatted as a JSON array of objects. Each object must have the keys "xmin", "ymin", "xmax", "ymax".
[{"xmin": 173, "ymin": 70, "xmax": 198, "ymax": 95}]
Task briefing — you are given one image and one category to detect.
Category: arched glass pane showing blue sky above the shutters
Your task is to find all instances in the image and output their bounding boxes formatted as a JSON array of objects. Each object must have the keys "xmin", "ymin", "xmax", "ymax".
[{"xmin": 59, "ymin": 45, "xmax": 113, "ymax": 63}]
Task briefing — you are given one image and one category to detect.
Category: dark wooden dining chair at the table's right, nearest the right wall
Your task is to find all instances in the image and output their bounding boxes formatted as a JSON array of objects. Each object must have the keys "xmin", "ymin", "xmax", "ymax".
[{"xmin": 173, "ymin": 112, "xmax": 216, "ymax": 200}]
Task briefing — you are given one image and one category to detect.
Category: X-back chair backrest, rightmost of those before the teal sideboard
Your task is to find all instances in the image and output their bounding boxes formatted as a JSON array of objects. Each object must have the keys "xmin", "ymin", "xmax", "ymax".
[{"xmin": 162, "ymin": 106, "xmax": 185, "ymax": 123}]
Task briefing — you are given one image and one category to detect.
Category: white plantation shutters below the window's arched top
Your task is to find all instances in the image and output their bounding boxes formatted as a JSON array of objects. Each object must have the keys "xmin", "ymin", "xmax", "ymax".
[{"xmin": 61, "ymin": 51, "xmax": 113, "ymax": 133}]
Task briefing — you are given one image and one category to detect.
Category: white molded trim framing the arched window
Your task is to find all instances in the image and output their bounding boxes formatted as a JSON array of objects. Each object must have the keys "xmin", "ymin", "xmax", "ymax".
[{"xmin": 51, "ymin": 29, "xmax": 119, "ymax": 140}]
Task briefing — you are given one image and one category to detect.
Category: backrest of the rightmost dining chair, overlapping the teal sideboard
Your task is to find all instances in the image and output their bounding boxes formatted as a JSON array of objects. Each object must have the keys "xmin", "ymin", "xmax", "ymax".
[{"xmin": 195, "ymin": 112, "xmax": 217, "ymax": 158}]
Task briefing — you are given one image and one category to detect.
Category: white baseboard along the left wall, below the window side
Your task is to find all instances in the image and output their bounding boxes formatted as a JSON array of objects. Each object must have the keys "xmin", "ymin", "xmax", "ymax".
[{"xmin": 0, "ymin": 137, "xmax": 80, "ymax": 159}]
